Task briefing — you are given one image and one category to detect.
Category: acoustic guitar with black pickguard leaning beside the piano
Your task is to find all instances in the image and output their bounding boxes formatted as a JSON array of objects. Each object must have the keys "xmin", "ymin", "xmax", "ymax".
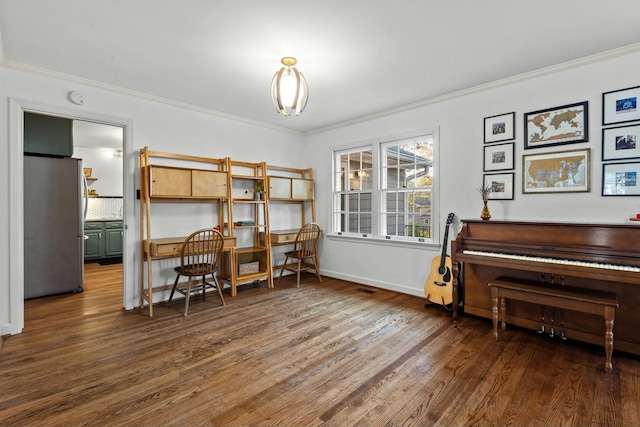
[{"xmin": 424, "ymin": 212, "xmax": 455, "ymax": 307}]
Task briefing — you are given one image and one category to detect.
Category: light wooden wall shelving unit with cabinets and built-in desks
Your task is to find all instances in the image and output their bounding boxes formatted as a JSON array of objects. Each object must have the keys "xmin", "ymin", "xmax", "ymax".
[{"xmin": 140, "ymin": 147, "xmax": 316, "ymax": 316}]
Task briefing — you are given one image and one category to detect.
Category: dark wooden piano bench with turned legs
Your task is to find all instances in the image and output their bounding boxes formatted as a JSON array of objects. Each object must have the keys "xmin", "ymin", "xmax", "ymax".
[{"xmin": 488, "ymin": 277, "xmax": 618, "ymax": 373}]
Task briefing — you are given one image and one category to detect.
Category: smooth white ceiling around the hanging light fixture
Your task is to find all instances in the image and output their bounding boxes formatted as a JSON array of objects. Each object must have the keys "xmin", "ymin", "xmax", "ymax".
[{"xmin": 0, "ymin": 0, "xmax": 640, "ymax": 133}]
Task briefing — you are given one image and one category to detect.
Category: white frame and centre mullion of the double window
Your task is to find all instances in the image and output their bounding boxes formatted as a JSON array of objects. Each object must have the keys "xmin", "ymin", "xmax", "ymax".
[{"xmin": 328, "ymin": 127, "xmax": 442, "ymax": 246}]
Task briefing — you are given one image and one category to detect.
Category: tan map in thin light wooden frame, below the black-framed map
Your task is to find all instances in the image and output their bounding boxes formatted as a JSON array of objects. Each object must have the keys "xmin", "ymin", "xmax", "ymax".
[{"xmin": 522, "ymin": 148, "xmax": 591, "ymax": 194}]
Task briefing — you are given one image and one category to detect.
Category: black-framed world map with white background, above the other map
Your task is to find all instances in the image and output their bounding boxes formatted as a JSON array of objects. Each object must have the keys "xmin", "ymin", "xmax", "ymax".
[{"xmin": 524, "ymin": 101, "xmax": 589, "ymax": 150}]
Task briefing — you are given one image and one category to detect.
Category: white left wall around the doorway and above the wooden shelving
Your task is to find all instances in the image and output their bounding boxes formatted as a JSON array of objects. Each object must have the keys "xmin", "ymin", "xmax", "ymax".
[{"xmin": 0, "ymin": 67, "xmax": 308, "ymax": 334}]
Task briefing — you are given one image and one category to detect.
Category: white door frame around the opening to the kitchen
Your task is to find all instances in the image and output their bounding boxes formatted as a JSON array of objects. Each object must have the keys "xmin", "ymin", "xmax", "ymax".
[{"xmin": 9, "ymin": 98, "xmax": 137, "ymax": 335}]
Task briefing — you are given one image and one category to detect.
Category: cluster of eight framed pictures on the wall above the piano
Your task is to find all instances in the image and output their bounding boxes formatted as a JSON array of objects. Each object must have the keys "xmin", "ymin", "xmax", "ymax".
[{"xmin": 483, "ymin": 86, "xmax": 640, "ymax": 200}]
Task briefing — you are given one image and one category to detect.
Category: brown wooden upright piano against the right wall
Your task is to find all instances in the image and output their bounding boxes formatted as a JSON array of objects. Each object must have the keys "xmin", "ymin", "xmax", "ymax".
[{"xmin": 451, "ymin": 220, "xmax": 640, "ymax": 355}]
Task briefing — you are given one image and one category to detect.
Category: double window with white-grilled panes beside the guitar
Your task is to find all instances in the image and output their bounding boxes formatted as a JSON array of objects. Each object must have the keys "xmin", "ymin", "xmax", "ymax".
[{"xmin": 333, "ymin": 130, "xmax": 437, "ymax": 243}]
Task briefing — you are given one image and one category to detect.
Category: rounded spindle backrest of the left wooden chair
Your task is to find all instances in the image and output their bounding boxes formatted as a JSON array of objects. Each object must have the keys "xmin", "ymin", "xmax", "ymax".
[{"xmin": 181, "ymin": 228, "xmax": 224, "ymax": 272}]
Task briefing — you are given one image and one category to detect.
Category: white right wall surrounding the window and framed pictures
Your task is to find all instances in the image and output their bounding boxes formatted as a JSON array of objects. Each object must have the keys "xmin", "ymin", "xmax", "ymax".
[{"xmin": 305, "ymin": 48, "xmax": 640, "ymax": 295}]
